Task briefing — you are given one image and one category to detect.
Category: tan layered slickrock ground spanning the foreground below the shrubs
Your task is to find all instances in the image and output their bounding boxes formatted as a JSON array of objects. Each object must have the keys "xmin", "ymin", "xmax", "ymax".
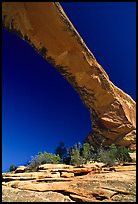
[{"xmin": 2, "ymin": 163, "xmax": 136, "ymax": 202}]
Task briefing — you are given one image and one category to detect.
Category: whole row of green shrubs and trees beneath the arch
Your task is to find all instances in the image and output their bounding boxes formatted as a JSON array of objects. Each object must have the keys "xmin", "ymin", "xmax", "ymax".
[{"xmin": 25, "ymin": 142, "xmax": 131, "ymax": 171}]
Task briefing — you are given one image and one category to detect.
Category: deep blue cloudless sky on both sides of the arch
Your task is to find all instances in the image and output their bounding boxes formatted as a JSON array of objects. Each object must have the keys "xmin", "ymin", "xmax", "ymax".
[{"xmin": 2, "ymin": 2, "xmax": 136, "ymax": 171}]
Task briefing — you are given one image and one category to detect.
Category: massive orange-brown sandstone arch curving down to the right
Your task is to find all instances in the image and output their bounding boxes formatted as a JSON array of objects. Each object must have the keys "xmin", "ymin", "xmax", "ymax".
[{"xmin": 2, "ymin": 2, "xmax": 136, "ymax": 148}]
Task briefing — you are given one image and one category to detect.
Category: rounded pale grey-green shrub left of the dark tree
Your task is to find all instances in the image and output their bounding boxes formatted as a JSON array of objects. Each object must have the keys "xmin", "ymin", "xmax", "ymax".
[{"xmin": 28, "ymin": 152, "xmax": 61, "ymax": 170}]
